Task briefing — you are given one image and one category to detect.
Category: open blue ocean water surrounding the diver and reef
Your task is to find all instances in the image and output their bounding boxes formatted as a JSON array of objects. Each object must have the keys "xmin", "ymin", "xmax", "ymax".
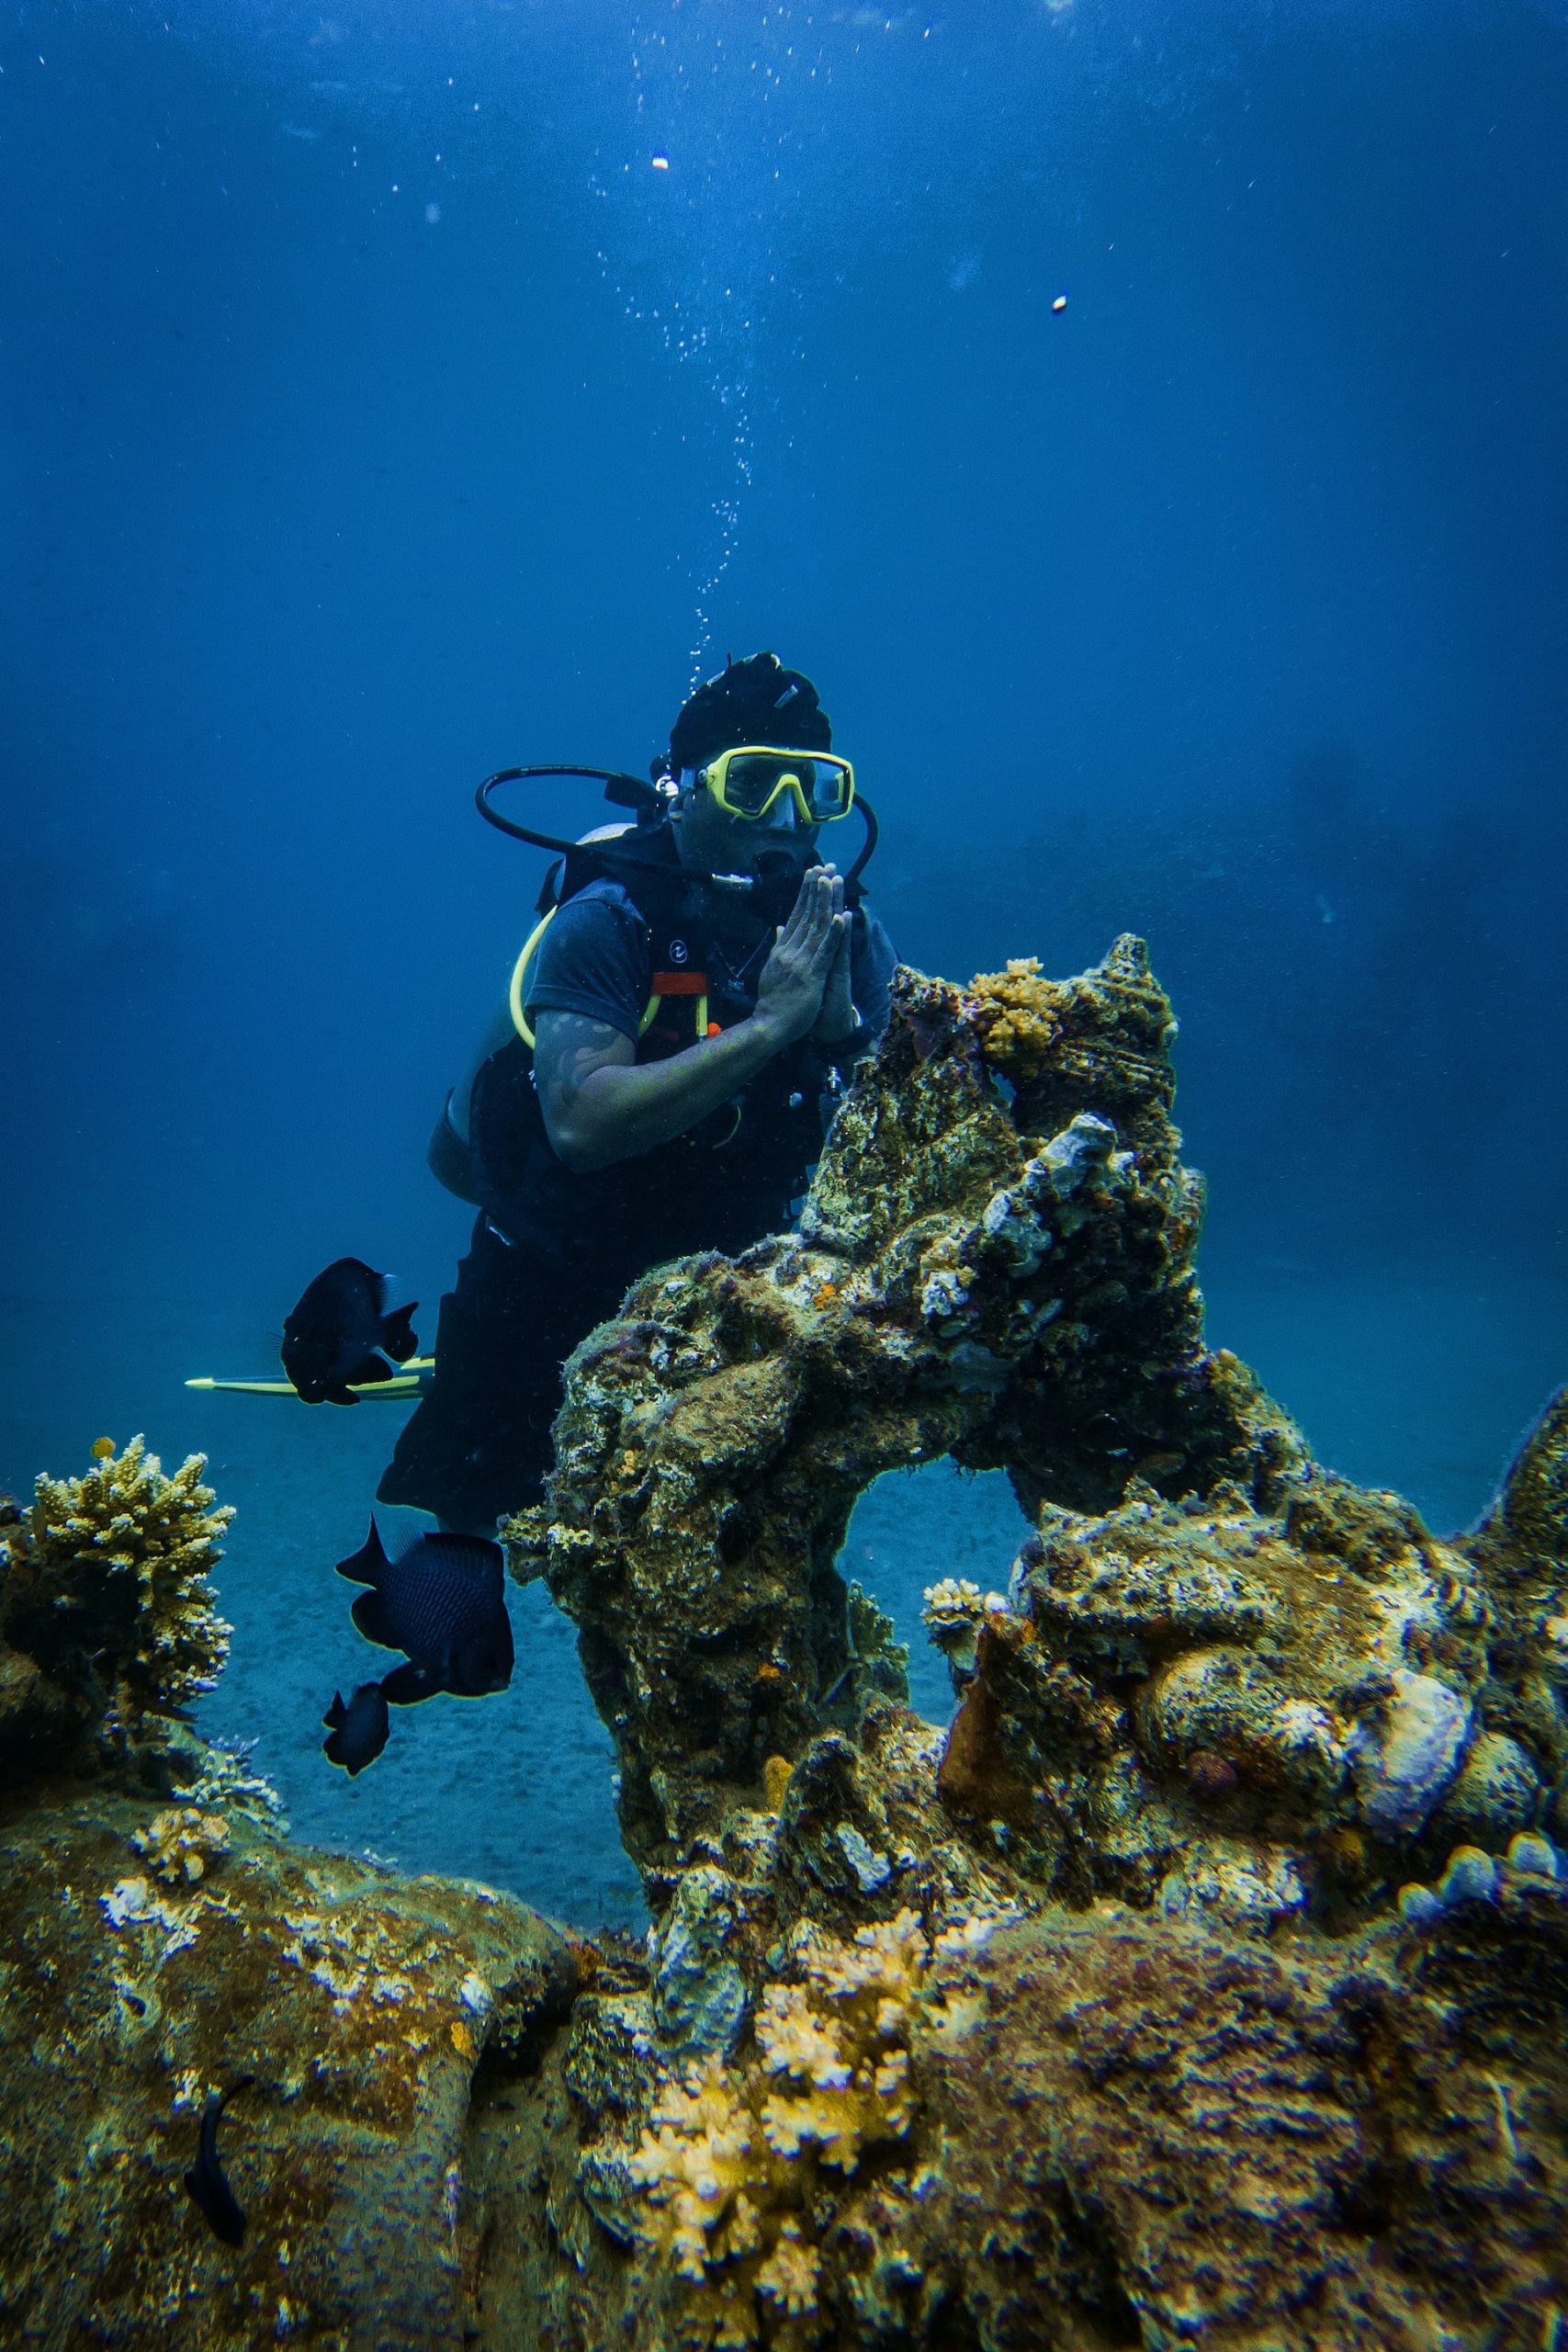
[{"xmin": 0, "ymin": 0, "xmax": 1568, "ymax": 1922}]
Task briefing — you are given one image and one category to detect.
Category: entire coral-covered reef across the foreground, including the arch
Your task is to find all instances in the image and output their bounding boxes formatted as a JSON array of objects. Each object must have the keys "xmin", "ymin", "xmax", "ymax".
[{"xmin": 0, "ymin": 938, "xmax": 1568, "ymax": 2352}]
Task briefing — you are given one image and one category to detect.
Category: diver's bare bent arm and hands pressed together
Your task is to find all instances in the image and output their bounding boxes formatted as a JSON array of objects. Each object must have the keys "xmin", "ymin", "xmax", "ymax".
[{"xmin": 534, "ymin": 865, "xmax": 856, "ymax": 1173}]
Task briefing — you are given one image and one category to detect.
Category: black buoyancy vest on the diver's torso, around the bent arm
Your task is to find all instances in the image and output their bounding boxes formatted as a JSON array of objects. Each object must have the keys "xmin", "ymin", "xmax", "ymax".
[{"xmin": 437, "ymin": 823, "xmax": 829, "ymax": 1282}]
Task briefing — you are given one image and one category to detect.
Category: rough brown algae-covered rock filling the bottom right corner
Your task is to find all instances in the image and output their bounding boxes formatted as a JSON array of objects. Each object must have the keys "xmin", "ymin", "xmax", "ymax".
[{"xmin": 907, "ymin": 1882, "xmax": 1568, "ymax": 2352}]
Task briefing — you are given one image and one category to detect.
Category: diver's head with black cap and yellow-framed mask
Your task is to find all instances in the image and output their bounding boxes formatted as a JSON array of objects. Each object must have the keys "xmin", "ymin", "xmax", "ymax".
[{"xmin": 668, "ymin": 654, "xmax": 853, "ymax": 900}]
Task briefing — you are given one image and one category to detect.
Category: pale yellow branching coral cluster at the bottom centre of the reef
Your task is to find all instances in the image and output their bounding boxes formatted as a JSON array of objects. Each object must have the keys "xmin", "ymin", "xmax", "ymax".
[{"xmin": 627, "ymin": 1910, "xmax": 971, "ymax": 2352}]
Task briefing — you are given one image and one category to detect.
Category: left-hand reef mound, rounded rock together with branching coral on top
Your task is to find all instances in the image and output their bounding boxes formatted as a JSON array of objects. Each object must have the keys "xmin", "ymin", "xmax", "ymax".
[{"xmin": 0, "ymin": 1440, "xmax": 594, "ymax": 2352}]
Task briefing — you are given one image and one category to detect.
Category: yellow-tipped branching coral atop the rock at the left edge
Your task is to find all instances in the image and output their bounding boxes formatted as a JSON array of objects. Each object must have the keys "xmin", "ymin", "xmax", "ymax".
[{"xmin": 0, "ymin": 1437, "xmax": 232, "ymax": 1724}]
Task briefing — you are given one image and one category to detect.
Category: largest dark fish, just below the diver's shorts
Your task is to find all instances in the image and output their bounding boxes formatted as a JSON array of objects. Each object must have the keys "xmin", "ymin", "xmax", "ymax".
[{"xmin": 339, "ymin": 1520, "xmax": 513, "ymax": 1708}]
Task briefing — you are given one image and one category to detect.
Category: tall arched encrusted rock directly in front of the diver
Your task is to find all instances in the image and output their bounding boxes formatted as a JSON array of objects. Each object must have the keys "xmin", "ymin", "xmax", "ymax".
[{"xmin": 508, "ymin": 941, "xmax": 1279, "ymax": 1905}]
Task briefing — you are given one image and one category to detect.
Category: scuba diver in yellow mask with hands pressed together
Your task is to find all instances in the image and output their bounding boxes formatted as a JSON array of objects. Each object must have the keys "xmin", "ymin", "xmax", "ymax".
[{"xmin": 378, "ymin": 654, "xmax": 896, "ymax": 1536}]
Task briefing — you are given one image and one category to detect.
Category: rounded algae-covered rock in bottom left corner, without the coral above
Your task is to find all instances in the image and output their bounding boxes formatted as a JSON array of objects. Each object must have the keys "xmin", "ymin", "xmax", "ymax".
[{"xmin": 0, "ymin": 1790, "xmax": 576, "ymax": 2352}]
